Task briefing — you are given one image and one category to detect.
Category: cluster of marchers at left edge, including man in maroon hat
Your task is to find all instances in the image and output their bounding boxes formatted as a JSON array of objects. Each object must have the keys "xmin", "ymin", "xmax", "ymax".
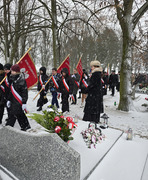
[{"xmin": 0, "ymin": 64, "xmax": 31, "ymax": 131}]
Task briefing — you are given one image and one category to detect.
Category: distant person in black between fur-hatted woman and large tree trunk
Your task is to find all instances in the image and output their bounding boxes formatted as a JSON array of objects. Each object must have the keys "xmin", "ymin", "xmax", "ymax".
[{"xmin": 109, "ymin": 70, "xmax": 118, "ymax": 96}]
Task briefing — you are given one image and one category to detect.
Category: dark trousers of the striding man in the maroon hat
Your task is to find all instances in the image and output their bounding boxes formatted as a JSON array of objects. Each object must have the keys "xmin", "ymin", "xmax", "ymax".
[{"xmin": 6, "ymin": 111, "xmax": 30, "ymax": 131}]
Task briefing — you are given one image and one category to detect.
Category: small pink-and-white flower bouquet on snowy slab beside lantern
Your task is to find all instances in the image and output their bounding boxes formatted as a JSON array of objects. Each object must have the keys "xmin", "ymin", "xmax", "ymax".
[{"xmin": 81, "ymin": 123, "xmax": 105, "ymax": 148}]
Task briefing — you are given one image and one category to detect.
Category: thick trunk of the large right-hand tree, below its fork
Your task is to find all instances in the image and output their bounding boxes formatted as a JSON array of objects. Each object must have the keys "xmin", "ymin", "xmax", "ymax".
[{"xmin": 118, "ymin": 26, "xmax": 133, "ymax": 111}]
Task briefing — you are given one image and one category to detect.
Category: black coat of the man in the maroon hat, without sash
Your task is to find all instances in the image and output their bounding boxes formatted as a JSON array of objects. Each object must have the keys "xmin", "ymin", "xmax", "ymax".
[{"xmin": 8, "ymin": 73, "xmax": 28, "ymax": 114}]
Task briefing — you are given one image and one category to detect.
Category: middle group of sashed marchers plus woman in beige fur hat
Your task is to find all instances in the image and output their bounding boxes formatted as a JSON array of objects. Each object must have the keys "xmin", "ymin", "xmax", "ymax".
[{"xmin": 37, "ymin": 60, "xmax": 103, "ymax": 123}]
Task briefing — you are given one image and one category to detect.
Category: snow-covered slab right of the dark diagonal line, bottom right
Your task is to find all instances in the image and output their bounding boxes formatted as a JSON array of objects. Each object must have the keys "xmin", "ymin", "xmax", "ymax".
[{"xmin": 88, "ymin": 134, "xmax": 148, "ymax": 180}]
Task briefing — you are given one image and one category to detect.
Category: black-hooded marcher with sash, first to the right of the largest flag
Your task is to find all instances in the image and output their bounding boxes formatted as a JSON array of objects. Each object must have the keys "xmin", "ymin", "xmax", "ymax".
[{"xmin": 37, "ymin": 67, "xmax": 49, "ymax": 111}]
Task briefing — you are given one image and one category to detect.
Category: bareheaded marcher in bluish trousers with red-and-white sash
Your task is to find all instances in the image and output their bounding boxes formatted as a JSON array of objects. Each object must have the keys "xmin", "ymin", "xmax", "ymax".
[{"xmin": 49, "ymin": 68, "xmax": 61, "ymax": 108}]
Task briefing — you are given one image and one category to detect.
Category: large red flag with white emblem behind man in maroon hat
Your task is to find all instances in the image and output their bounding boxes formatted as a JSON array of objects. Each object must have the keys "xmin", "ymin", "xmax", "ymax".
[{"xmin": 17, "ymin": 53, "xmax": 38, "ymax": 89}]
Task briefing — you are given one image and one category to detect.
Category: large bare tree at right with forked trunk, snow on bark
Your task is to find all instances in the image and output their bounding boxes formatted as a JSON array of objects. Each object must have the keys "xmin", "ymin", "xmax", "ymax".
[{"xmin": 115, "ymin": 0, "xmax": 148, "ymax": 111}]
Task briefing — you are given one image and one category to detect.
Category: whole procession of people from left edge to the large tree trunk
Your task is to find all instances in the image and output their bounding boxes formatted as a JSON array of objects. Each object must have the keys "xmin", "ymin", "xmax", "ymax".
[{"xmin": 0, "ymin": 60, "xmax": 118, "ymax": 131}]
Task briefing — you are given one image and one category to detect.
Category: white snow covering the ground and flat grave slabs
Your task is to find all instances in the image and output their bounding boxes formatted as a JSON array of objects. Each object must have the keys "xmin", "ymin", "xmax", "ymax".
[{"xmin": 0, "ymin": 91, "xmax": 148, "ymax": 180}]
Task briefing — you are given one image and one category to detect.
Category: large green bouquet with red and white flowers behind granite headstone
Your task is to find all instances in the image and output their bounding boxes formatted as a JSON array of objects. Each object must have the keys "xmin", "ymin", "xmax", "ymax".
[{"xmin": 30, "ymin": 107, "xmax": 77, "ymax": 142}]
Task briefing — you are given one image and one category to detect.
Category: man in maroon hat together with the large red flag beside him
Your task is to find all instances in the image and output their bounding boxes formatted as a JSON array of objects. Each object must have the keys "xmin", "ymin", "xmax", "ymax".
[{"xmin": 1, "ymin": 48, "xmax": 38, "ymax": 131}]
